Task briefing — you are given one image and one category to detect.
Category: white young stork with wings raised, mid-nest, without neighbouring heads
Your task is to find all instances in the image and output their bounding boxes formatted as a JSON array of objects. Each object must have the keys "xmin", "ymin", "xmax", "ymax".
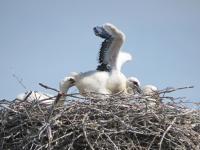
[{"xmin": 61, "ymin": 23, "xmax": 132, "ymax": 96}]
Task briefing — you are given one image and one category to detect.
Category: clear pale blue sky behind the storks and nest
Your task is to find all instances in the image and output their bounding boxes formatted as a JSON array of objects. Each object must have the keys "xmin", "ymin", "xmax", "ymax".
[{"xmin": 0, "ymin": 0, "xmax": 200, "ymax": 101}]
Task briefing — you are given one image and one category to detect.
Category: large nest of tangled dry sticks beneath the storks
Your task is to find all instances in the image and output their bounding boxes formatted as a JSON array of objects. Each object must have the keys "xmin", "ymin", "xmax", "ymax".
[{"xmin": 0, "ymin": 86, "xmax": 200, "ymax": 150}]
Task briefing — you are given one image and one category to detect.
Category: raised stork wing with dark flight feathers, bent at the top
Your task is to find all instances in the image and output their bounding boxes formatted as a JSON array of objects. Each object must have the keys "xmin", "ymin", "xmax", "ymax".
[{"xmin": 94, "ymin": 23, "xmax": 125, "ymax": 71}]
